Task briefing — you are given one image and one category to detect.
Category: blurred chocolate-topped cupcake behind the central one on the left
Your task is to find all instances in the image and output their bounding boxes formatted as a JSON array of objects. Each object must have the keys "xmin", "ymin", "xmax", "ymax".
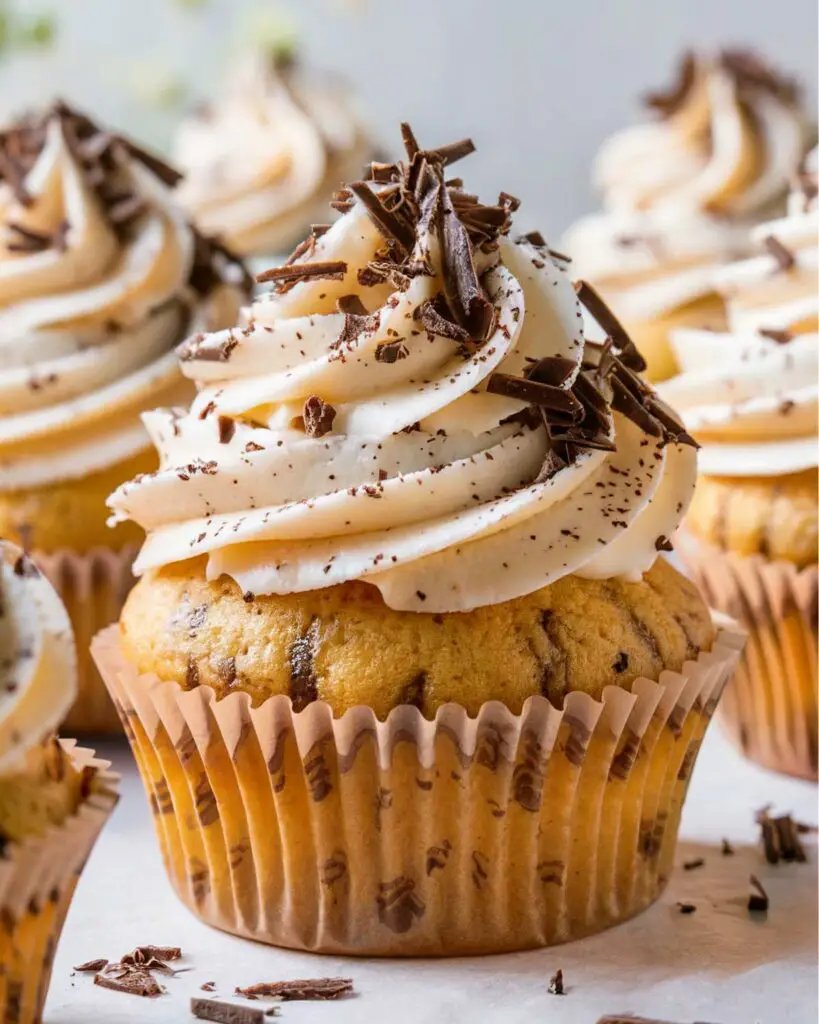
[{"xmin": 0, "ymin": 103, "xmax": 249, "ymax": 731}]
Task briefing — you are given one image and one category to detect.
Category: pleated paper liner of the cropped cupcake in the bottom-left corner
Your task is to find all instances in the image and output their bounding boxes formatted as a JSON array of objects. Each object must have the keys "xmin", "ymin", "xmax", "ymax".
[{"xmin": 0, "ymin": 740, "xmax": 118, "ymax": 1024}]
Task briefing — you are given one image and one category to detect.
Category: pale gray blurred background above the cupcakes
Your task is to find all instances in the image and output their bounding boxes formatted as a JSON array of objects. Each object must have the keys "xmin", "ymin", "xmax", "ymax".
[{"xmin": 0, "ymin": 0, "xmax": 818, "ymax": 238}]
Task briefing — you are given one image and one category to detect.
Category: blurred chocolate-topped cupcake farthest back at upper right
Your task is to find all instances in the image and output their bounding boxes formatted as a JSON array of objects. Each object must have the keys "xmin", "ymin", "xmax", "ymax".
[{"xmin": 561, "ymin": 50, "xmax": 810, "ymax": 381}]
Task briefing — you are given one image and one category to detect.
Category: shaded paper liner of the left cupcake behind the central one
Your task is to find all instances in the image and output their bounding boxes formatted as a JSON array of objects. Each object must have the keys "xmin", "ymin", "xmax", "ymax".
[{"xmin": 32, "ymin": 545, "xmax": 138, "ymax": 735}]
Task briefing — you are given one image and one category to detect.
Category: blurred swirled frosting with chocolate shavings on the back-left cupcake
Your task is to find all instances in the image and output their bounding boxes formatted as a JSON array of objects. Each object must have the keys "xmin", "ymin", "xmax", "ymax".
[{"xmin": 0, "ymin": 104, "xmax": 249, "ymax": 489}]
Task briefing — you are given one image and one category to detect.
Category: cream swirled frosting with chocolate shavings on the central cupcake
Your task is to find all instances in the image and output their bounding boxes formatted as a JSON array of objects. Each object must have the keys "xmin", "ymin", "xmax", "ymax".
[{"xmin": 111, "ymin": 126, "xmax": 696, "ymax": 611}]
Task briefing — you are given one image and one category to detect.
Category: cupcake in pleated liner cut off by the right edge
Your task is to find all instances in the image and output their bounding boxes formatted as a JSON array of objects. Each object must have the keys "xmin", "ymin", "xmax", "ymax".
[{"xmin": 663, "ymin": 151, "xmax": 819, "ymax": 779}]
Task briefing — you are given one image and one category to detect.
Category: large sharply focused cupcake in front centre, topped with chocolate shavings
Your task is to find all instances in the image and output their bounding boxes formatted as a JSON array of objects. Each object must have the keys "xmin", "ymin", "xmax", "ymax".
[{"xmin": 94, "ymin": 126, "xmax": 740, "ymax": 955}]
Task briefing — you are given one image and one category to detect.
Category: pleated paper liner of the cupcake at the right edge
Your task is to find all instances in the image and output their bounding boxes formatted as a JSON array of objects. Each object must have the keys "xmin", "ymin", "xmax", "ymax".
[{"xmin": 677, "ymin": 532, "xmax": 819, "ymax": 781}]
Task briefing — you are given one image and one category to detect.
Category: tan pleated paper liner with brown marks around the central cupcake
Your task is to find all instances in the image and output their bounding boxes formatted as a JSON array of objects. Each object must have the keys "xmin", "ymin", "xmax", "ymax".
[{"xmin": 93, "ymin": 627, "xmax": 742, "ymax": 955}]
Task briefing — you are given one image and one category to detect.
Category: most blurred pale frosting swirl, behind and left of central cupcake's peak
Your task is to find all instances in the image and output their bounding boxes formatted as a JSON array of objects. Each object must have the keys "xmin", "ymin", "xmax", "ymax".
[{"xmin": 175, "ymin": 54, "xmax": 372, "ymax": 256}]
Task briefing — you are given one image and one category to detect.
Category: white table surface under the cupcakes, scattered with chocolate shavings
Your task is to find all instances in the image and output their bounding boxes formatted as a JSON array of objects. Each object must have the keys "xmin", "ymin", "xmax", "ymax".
[{"xmin": 45, "ymin": 725, "xmax": 819, "ymax": 1024}]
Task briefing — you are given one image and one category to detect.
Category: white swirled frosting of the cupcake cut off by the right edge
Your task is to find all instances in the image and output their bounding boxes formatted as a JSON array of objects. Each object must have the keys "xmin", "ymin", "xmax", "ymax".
[{"xmin": 660, "ymin": 151, "xmax": 819, "ymax": 476}]
